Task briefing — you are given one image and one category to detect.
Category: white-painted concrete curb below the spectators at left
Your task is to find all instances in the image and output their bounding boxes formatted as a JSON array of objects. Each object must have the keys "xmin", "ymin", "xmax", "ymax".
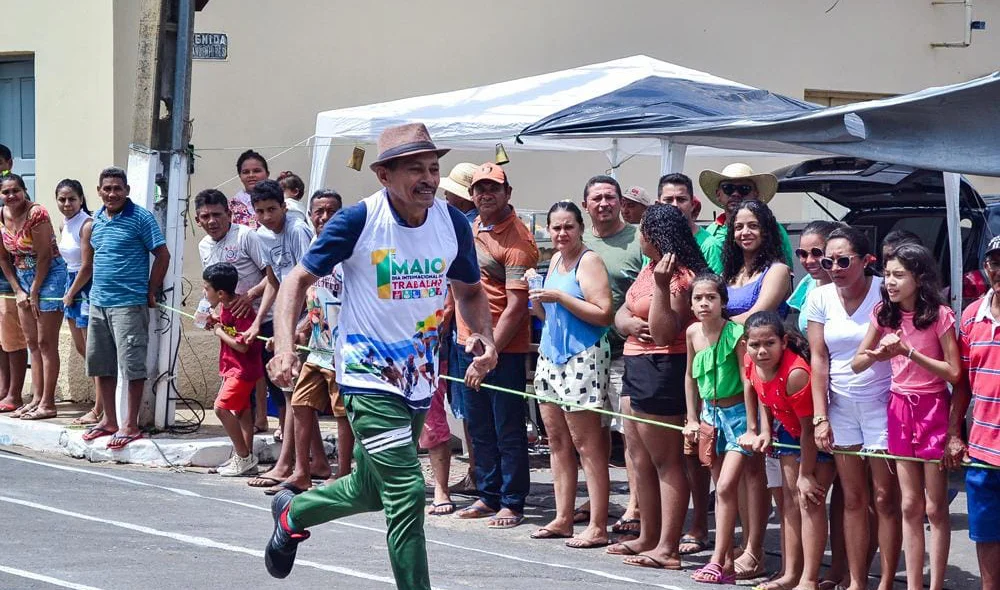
[{"xmin": 0, "ymin": 417, "xmax": 336, "ymax": 467}]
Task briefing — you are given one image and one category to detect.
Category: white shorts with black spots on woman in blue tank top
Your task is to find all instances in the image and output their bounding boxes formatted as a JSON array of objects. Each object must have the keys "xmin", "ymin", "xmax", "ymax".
[{"xmin": 535, "ymin": 338, "xmax": 611, "ymax": 412}]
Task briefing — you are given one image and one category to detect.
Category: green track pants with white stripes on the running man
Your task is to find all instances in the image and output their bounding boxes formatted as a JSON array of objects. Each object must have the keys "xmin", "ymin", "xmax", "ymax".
[{"xmin": 289, "ymin": 393, "xmax": 431, "ymax": 590}]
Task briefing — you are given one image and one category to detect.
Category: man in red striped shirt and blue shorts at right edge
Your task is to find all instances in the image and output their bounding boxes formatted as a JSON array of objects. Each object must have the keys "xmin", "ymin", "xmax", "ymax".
[{"xmin": 945, "ymin": 236, "xmax": 1000, "ymax": 590}]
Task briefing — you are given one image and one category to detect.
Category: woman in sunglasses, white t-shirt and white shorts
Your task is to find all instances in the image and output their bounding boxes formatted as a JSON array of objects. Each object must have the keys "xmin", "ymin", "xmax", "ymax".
[{"xmin": 805, "ymin": 227, "xmax": 902, "ymax": 590}]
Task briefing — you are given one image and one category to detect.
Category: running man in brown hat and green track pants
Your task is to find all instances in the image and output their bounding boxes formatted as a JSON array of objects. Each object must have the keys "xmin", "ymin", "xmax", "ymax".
[{"xmin": 264, "ymin": 123, "xmax": 496, "ymax": 589}]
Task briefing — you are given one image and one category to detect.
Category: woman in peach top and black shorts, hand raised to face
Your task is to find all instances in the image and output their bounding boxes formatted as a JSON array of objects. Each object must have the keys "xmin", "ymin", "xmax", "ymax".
[{"xmin": 608, "ymin": 203, "xmax": 708, "ymax": 569}]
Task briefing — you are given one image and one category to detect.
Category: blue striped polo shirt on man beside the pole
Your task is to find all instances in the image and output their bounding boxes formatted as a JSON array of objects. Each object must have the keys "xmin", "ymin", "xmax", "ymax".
[{"xmin": 90, "ymin": 199, "xmax": 166, "ymax": 307}]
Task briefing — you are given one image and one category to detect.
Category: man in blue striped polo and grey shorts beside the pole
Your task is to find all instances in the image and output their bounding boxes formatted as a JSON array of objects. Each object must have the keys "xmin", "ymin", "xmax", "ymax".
[{"xmin": 83, "ymin": 167, "xmax": 170, "ymax": 450}]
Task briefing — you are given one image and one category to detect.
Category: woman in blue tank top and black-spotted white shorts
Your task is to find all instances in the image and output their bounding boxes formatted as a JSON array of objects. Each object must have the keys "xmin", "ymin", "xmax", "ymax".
[{"xmin": 525, "ymin": 201, "xmax": 614, "ymax": 549}]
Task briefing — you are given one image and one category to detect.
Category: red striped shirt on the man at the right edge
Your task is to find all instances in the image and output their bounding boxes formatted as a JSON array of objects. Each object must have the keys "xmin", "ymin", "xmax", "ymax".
[{"xmin": 958, "ymin": 291, "xmax": 1000, "ymax": 465}]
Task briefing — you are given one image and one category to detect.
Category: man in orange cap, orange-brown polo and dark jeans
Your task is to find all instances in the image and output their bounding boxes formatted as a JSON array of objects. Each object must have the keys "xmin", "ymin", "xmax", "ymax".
[{"xmin": 455, "ymin": 162, "xmax": 538, "ymax": 529}]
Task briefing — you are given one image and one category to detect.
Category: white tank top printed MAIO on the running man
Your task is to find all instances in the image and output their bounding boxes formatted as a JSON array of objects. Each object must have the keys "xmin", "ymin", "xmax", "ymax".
[{"xmin": 336, "ymin": 191, "xmax": 458, "ymax": 408}]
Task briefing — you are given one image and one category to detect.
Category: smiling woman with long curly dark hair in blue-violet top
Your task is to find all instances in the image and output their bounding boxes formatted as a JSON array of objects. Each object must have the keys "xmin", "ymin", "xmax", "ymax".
[{"xmin": 722, "ymin": 201, "xmax": 791, "ymax": 580}]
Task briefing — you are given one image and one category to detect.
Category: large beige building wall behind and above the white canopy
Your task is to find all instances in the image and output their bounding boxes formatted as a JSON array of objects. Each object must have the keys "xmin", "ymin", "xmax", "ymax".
[{"xmin": 186, "ymin": 0, "xmax": 1000, "ymax": 220}]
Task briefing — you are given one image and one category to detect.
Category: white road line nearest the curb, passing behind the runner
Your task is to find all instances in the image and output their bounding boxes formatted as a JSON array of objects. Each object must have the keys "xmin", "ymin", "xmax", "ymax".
[{"xmin": 0, "ymin": 453, "xmax": 684, "ymax": 590}]
